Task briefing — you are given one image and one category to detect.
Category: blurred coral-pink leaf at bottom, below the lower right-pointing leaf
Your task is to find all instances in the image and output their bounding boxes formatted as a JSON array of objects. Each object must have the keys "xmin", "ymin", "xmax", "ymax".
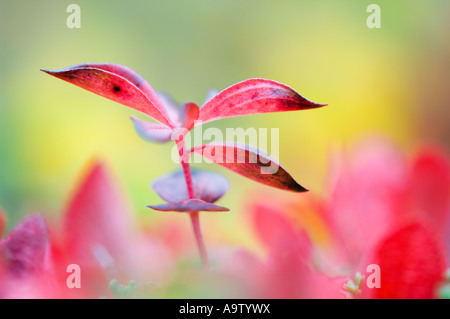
[{"xmin": 251, "ymin": 204, "xmax": 336, "ymax": 299}]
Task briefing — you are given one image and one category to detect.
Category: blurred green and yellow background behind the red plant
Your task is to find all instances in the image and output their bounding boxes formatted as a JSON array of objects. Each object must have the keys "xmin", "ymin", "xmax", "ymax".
[{"xmin": 0, "ymin": 0, "xmax": 450, "ymax": 248}]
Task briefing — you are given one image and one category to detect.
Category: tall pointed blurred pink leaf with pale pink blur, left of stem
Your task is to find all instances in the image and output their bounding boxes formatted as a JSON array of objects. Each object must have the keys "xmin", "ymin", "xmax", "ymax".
[{"xmin": 53, "ymin": 162, "xmax": 173, "ymax": 298}]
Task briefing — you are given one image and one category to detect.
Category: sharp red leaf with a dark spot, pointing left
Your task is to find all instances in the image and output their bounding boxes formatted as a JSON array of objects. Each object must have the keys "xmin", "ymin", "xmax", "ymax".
[{"xmin": 42, "ymin": 63, "xmax": 174, "ymax": 127}]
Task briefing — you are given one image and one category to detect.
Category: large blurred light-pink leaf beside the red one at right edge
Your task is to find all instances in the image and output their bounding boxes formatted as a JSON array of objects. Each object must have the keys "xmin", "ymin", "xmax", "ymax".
[{"xmin": 325, "ymin": 140, "xmax": 407, "ymax": 272}]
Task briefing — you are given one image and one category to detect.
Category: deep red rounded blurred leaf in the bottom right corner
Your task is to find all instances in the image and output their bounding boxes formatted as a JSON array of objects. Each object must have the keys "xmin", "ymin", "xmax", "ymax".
[{"xmin": 372, "ymin": 223, "xmax": 445, "ymax": 299}]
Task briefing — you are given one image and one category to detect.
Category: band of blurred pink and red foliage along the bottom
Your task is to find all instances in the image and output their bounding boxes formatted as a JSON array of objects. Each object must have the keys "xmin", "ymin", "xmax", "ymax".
[{"xmin": 0, "ymin": 141, "xmax": 450, "ymax": 298}]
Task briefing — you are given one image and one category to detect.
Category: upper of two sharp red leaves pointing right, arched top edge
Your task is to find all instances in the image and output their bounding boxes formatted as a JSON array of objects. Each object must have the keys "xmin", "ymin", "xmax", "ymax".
[{"xmin": 199, "ymin": 79, "xmax": 326, "ymax": 123}]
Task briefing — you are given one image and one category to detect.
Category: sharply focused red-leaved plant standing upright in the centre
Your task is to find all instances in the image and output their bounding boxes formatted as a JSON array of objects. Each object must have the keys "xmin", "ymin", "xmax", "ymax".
[{"xmin": 42, "ymin": 63, "xmax": 326, "ymax": 267}]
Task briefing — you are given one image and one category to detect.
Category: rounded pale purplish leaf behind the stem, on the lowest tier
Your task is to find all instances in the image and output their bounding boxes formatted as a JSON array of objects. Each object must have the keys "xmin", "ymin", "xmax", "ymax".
[{"xmin": 152, "ymin": 171, "xmax": 229, "ymax": 203}]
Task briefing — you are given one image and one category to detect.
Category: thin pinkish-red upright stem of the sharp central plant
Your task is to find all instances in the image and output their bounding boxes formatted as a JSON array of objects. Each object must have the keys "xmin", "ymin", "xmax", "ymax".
[{"xmin": 176, "ymin": 136, "xmax": 209, "ymax": 268}]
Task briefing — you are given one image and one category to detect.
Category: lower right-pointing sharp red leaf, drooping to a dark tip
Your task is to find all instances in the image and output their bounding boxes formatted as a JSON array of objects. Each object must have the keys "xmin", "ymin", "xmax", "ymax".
[{"xmin": 190, "ymin": 143, "xmax": 307, "ymax": 192}]
